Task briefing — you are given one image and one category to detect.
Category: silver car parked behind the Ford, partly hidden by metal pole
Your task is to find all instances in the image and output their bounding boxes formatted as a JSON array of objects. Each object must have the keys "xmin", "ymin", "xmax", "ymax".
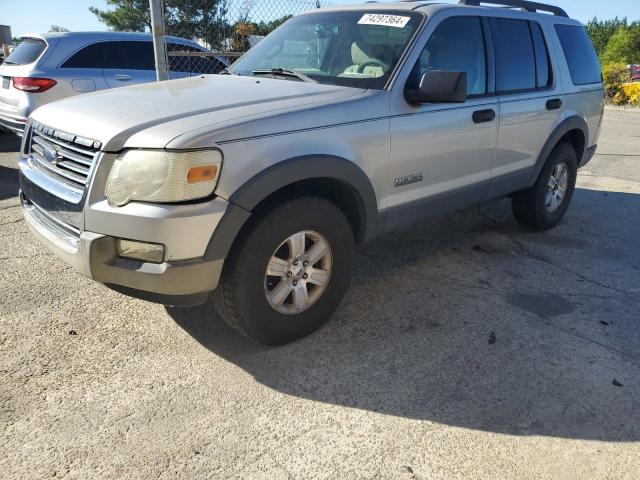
[{"xmin": 0, "ymin": 32, "xmax": 227, "ymax": 135}]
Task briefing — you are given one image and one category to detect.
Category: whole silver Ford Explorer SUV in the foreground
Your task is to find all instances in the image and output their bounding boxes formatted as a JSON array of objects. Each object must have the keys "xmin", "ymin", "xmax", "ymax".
[{"xmin": 20, "ymin": 0, "xmax": 604, "ymax": 344}]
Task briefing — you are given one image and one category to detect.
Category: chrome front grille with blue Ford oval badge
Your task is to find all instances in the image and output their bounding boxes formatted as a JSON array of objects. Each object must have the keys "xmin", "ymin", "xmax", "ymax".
[{"xmin": 25, "ymin": 122, "xmax": 100, "ymax": 191}]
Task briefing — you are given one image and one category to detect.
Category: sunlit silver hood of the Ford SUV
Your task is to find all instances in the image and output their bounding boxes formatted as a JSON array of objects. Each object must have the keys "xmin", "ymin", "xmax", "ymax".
[{"xmin": 32, "ymin": 75, "xmax": 365, "ymax": 151}]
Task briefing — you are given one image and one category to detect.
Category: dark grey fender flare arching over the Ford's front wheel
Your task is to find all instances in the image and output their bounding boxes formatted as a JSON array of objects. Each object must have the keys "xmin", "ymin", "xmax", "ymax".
[{"xmin": 204, "ymin": 155, "xmax": 383, "ymax": 260}]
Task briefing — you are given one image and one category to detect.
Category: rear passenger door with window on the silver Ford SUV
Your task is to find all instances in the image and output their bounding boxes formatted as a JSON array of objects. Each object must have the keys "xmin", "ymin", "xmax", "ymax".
[{"xmin": 489, "ymin": 18, "xmax": 563, "ymax": 197}]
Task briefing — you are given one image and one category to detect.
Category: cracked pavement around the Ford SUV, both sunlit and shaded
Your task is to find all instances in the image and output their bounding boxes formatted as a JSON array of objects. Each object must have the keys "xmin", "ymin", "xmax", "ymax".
[{"xmin": 0, "ymin": 110, "xmax": 640, "ymax": 480}]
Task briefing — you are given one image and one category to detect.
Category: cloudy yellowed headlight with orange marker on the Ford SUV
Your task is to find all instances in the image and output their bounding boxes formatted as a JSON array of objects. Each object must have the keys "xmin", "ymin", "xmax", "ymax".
[{"xmin": 105, "ymin": 149, "xmax": 222, "ymax": 206}]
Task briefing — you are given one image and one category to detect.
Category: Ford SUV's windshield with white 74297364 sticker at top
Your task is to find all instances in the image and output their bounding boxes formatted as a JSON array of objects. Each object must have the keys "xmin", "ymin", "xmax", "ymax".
[{"xmin": 229, "ymin": 11, "xmax": 422, "ymax": 89}]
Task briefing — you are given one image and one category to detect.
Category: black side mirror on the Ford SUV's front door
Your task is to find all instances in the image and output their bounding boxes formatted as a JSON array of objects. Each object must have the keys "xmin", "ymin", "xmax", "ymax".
[{"xmin": 404, "ymin": 70, "xmax": 467, "ymax": 104}]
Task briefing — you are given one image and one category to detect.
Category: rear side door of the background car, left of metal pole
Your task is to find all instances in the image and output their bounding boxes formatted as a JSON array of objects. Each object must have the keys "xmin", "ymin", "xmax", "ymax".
[{"xmin": 103, "ymin": 40, "xmax": 156, "ymax": 88}]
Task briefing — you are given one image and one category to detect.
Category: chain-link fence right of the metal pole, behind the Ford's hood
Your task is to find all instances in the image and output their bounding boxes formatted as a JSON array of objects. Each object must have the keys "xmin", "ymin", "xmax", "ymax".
[{"xmin": 152, "ymin": 0, "xmax": 330, "ymax": 73}]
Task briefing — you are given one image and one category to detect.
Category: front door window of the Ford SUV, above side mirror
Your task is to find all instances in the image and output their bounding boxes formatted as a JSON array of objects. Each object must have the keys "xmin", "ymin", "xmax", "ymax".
[{"xmin": 416, "ymin": 17, "xmax": 487, "ymax": 95}]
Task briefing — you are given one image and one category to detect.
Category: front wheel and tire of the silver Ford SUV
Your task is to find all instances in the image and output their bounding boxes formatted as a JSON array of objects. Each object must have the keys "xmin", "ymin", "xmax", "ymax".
[{"xmin": 213, "ymin": 197, "xmax": 354, "ymax": 345}]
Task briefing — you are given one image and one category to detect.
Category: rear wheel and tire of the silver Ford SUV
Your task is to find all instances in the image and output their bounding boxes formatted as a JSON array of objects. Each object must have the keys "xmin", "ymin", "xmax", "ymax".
[{"xmin": 511, "ymin": 143, "xmax": 578, "ymax": 230}]
